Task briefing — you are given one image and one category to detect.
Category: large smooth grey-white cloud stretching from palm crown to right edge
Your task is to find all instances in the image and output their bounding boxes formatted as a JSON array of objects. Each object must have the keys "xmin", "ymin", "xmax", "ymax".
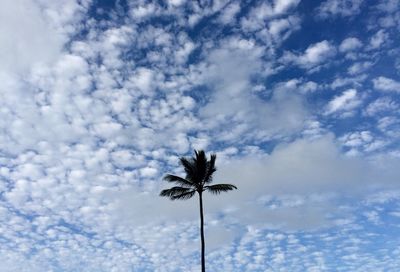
[{"xmin": 202, "ymin": 136, "xmax": 398, "ymax": 228}]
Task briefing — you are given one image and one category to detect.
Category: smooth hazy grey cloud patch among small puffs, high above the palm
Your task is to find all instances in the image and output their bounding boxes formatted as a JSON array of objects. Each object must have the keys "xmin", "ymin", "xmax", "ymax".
[{"xmin": 201, "ymin": 43, "xmax": 308, "ymax": 140}]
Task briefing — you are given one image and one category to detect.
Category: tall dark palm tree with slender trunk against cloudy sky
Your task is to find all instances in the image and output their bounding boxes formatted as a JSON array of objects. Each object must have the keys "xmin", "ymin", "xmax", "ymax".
[{"xmin": 160, "ymin": 150, "xmax": 237, "ymax": 272}]
